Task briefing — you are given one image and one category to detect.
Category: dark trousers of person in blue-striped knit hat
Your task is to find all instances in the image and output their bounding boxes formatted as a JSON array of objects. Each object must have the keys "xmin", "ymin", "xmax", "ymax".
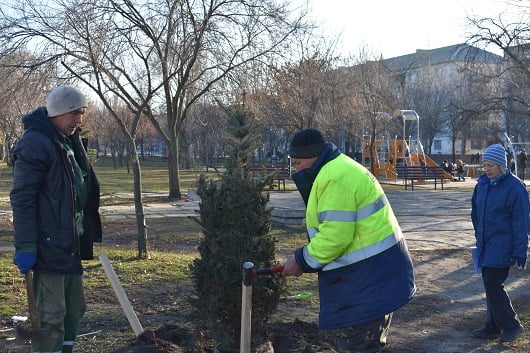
[{"xmin": 482, "ymin": 267, "xmax": 519, "ymax": 331}]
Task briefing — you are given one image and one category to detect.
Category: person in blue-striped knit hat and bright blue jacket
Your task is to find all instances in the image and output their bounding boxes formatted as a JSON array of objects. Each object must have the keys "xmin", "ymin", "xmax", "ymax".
[{"xmin": 471, "ymin": 144, "xmax": 530, "ymax": 342}]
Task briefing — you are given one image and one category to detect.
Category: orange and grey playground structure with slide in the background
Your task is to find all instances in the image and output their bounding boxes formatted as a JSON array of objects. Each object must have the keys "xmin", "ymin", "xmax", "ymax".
[{"xmin": 362, "ymin": 110, "xmax": 454, "ymax": 180}]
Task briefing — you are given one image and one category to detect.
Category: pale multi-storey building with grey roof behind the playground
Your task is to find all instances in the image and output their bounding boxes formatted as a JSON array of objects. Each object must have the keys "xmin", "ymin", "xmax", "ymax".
[{"xmin": 384, "ymin": 44, "xmax": 503, "ymax": 163}]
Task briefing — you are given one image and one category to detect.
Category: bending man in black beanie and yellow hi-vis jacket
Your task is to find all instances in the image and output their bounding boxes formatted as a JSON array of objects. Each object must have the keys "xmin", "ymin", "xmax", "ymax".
[{"xmin": 282, "ymin": 129, "xmax": 416, "ymax": 353}]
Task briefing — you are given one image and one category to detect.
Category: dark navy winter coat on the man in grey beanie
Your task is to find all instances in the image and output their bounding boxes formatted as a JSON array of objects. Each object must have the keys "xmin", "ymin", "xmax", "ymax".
[{"xmin": 10, "ymin": 107, "xmax": 102, "ymax": 274}]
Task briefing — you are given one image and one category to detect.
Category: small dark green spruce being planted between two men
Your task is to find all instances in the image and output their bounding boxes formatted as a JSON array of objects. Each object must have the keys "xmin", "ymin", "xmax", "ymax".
[{"xmin": 190, "ymin": 101, "xmax": 285, "ymax": 352}]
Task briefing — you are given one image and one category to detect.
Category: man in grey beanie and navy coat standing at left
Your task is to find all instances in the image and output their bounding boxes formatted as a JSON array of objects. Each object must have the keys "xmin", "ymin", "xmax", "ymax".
[{"xmin": 10, "ymin": 86, "xmax": 102, "ymax": 353}]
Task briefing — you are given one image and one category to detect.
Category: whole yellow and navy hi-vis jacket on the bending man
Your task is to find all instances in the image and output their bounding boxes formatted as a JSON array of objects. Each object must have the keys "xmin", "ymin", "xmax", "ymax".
[{"xmin": 295, "ymin": 154, "xmax": 416, "ymax": 330}]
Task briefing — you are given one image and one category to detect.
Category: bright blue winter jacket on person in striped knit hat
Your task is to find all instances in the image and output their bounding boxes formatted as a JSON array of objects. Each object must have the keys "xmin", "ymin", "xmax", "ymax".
[{"xmin": 471, "ymin": 171, "xmax": 530, "ymax": 268}]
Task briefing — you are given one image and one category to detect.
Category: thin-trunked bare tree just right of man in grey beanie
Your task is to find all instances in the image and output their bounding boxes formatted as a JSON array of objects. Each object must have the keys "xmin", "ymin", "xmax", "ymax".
[{"xmin": 0, "ymin": 0, "xmax": 154, "ymax": 258}]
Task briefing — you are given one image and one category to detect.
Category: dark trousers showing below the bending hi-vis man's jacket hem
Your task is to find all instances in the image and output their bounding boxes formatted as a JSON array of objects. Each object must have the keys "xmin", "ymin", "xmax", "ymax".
[{"xmin": 335, "ymin": 313, "xmax": 392, "ymax": 353}]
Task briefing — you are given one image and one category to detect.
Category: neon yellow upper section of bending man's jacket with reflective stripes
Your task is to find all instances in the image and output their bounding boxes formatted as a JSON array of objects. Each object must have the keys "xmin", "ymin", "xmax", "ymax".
[{"xmin": 304, "ymin": 154, "xmax": 403, "ymax": 271}]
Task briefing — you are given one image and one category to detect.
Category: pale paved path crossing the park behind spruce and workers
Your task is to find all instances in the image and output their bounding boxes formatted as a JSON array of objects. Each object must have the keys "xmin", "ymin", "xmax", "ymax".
[{"xmin": 0, "ymin": 179, "xmax": 476, "ymax": 250}]
